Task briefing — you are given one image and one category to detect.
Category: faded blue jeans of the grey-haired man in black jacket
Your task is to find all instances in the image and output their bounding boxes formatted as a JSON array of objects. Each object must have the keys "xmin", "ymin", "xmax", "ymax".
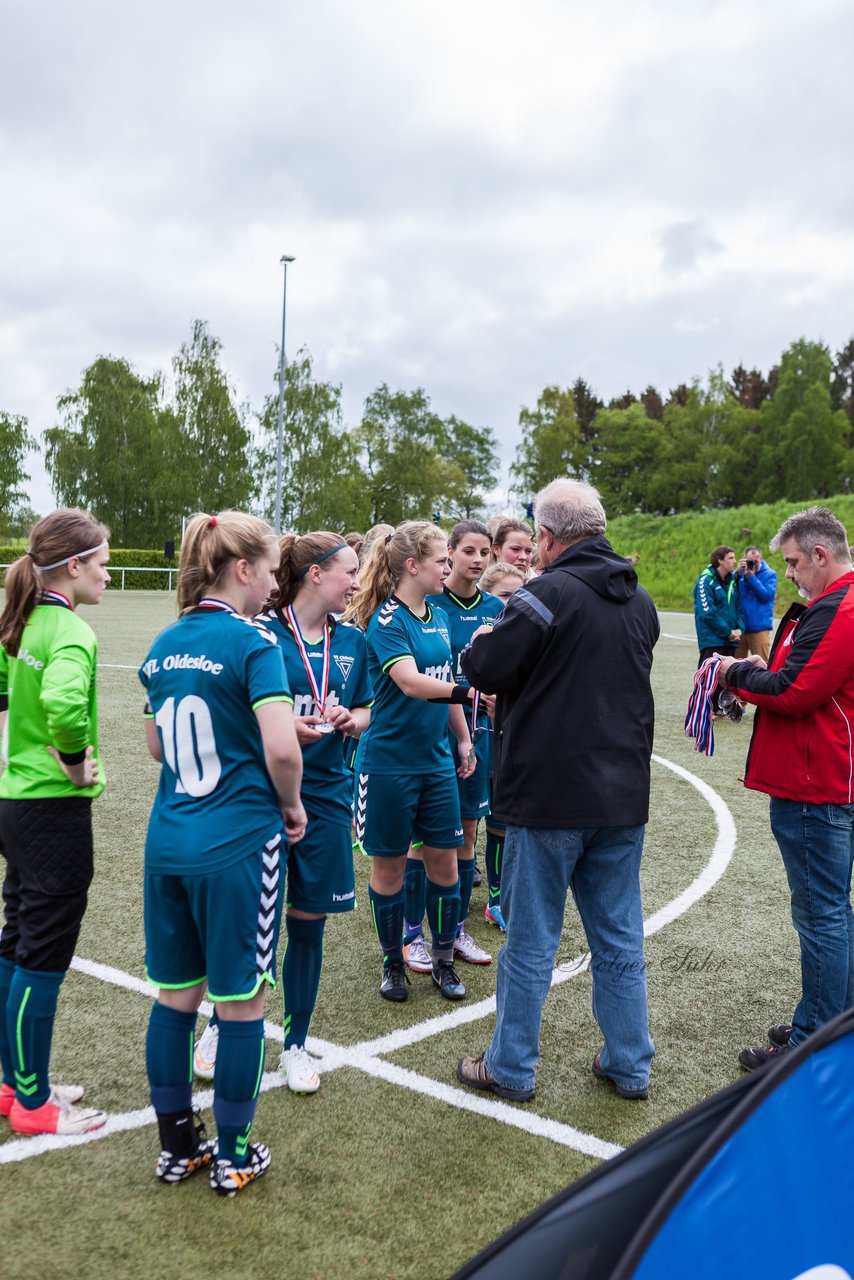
[{"xmin": 487, "ymin": 827, "xmax": 656, "ymax": 1089}]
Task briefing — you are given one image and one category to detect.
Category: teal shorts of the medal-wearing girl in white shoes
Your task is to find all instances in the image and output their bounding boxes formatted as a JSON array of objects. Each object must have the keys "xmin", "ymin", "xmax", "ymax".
[{"xmin": 286, "ymin": 806, "xmax": 356, "ymax": 915}]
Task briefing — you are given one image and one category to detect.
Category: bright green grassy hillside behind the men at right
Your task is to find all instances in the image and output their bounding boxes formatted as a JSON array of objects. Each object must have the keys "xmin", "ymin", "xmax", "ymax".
[{"xmin": 608, "ymin": 494, "xmax": 854, "ymax": 613}]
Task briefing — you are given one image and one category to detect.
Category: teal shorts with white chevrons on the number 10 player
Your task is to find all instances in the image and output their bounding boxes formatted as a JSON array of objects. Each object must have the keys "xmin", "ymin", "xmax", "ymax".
[{"xmin": 145, "ymin": 835, "xmax": 287, "ymax": 1000}]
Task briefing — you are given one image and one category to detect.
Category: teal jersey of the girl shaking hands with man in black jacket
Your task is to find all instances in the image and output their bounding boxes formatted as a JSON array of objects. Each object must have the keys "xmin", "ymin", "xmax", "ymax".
[{"xmin": 356, "ymin": 595, "xmax": 456, "ymax": 774}]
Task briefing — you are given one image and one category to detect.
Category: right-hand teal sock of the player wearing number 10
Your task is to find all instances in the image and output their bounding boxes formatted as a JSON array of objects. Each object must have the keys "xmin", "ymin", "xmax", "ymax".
[{"xmin": 214, "ymin": 1018, "xmax": 265, "ymax": 1167}]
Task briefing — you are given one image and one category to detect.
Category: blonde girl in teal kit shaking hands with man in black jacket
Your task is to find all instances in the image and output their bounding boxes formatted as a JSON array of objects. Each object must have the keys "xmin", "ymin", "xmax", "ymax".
[{"xmin": 348, "ymin": 521, "xmax": 475, "ymax": 1001}]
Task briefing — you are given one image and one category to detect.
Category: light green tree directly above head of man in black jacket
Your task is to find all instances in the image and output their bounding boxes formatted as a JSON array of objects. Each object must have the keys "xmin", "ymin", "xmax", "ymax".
[{"xmin": 510, "ymin": 387, "xmax": 583, "ymax": 499}]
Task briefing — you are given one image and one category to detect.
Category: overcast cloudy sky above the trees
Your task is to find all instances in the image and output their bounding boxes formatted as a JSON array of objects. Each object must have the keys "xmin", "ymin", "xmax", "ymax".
[{"xmin": 0, "ymin": 0, "xmax": 854, "ymax": 511}]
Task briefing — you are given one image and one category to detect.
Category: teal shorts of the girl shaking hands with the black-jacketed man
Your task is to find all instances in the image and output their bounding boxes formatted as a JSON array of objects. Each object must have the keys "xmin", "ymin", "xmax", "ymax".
[{"xmin": 356, "ymin": 773, "xmax": 463, "ymax": 858}]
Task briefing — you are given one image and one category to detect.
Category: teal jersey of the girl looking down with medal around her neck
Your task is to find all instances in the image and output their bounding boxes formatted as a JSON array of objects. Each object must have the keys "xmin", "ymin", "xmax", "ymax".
[{"xmin": 260, "ymin": 609, "xmax": 373, "ymax": 829}]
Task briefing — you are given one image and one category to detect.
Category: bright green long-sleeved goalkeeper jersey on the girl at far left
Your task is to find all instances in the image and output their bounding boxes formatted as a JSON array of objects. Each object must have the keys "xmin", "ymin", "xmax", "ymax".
[{"xmin": 0, "ymin": 599, "xmax": 104, "ymax": 800}]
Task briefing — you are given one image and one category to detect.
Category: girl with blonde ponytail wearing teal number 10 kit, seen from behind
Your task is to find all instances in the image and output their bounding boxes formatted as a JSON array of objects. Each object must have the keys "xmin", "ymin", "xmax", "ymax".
[{"xmin": 140, "ymin": 511, "xmax": 306, "ymax": 1196}]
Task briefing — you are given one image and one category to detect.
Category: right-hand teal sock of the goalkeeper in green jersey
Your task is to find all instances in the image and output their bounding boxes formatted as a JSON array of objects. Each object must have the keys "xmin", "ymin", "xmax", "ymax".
[{"xmin": 6, "ymin": 966, "xmax": 65, "ymax": 1111}]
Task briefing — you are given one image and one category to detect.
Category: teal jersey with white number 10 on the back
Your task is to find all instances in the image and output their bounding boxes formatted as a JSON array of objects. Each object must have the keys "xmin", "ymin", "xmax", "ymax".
[{"xmin": 140, "ymin": 607, "xmax": 293, "ymax": 876}]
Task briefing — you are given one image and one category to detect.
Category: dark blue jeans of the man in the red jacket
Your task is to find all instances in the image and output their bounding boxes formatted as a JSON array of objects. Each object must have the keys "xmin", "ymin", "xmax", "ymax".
[{"xmin": 771, "ymin": 796, "xmax": 854, "ymax": 1044}]
